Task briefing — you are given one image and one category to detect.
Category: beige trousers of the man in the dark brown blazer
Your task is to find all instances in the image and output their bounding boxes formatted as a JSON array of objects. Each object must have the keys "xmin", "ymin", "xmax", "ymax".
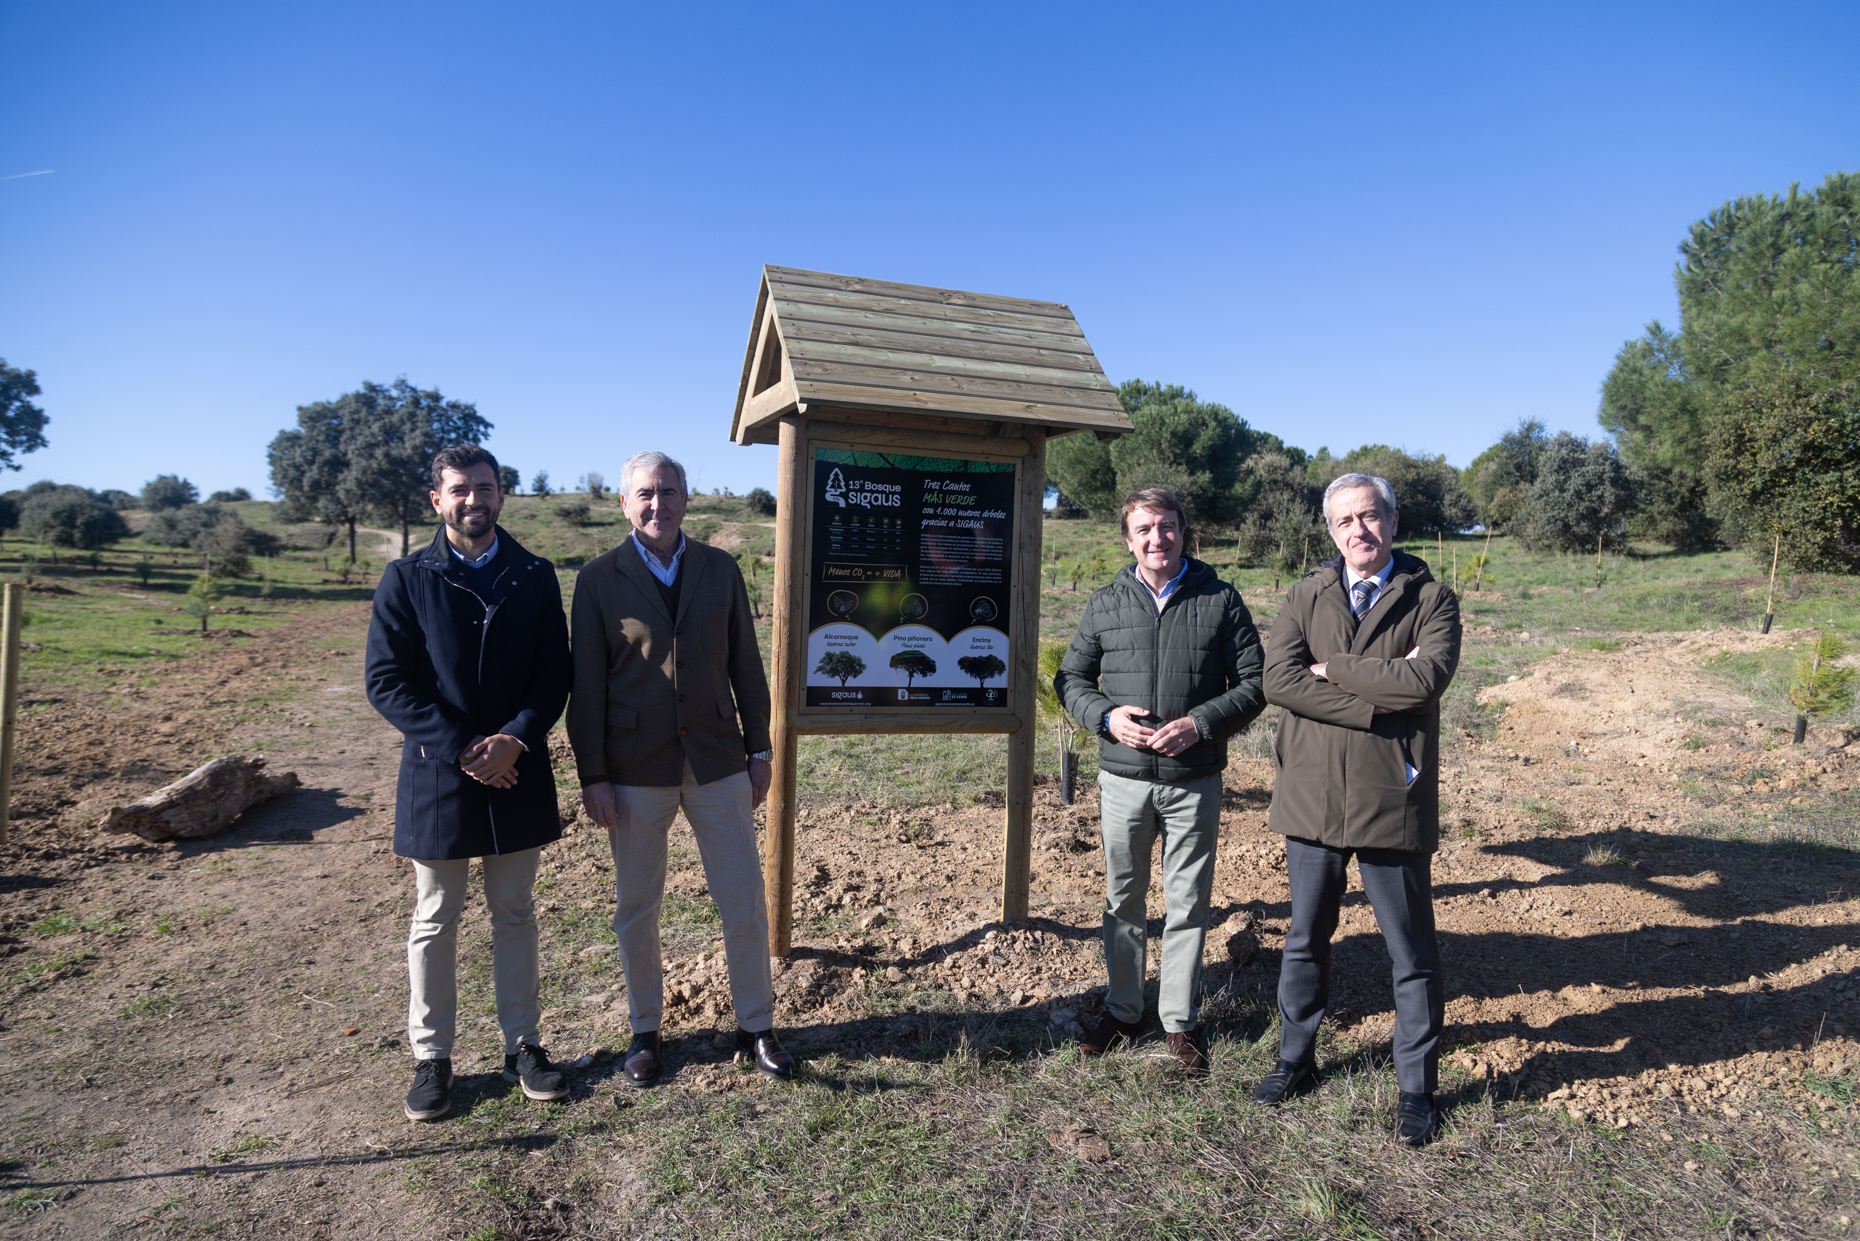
[{"xmin": 606, "ymin": 763, "xmax": 776, "ymax": 1034}]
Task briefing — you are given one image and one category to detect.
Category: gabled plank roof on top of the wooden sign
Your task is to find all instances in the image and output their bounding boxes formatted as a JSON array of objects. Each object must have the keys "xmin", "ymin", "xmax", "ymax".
[{"xmin": 729, "ymin": 266, "xmax": 1133, "ymax": 445}]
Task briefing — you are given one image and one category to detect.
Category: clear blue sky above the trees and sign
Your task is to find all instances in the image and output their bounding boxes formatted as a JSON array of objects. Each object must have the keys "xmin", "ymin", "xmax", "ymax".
[{"xmin": 0, "ymin": 0, "xmax": 1860, "ymax": 495}]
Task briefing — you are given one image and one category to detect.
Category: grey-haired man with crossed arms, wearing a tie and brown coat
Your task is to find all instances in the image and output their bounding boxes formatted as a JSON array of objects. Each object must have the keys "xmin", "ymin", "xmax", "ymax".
[{"xmin": 1254, "ymin": 474, "xmax": 1460, "ymax": 1146}]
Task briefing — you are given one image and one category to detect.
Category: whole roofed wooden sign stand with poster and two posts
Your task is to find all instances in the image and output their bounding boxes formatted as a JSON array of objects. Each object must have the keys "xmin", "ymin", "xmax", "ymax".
[{"xmin": 731, "ymin": 266, "xmax": 1131, "ymax": 956}]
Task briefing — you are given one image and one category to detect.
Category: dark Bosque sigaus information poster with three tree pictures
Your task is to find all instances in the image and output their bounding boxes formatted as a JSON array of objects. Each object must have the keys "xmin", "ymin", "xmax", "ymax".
[{"xmin": 807, "ymin": 448, "xmax": 1014, "ymax": 711}]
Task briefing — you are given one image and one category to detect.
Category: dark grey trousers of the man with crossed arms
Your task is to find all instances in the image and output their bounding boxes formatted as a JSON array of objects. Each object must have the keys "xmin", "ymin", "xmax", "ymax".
[{"xmin": 1280, "ymin": 835, "xmax": 1447, "ymax": 1094}]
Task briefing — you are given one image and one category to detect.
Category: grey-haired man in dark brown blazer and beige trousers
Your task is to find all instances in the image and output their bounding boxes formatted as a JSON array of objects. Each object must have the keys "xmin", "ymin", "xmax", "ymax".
[{"xmin": 569, "ymin": 452, "xmax": 794, "ymax": 1087}]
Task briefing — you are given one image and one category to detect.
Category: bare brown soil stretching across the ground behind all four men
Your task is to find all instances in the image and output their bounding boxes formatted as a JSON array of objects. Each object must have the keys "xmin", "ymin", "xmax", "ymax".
[{"xmin": 0, "ymin": 605, "xmax": 1860, "ymax": 1237}]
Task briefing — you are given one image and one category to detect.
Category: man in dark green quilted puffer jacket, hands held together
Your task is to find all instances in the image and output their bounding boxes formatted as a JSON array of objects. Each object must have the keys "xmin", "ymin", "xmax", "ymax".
[{"xmin": 1053, "ymin": 487, "xmax": 1265, "ymax": 1077}]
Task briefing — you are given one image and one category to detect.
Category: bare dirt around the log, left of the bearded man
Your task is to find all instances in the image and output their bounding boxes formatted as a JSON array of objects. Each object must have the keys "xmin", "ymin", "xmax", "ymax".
[{"xmin": 0, "ymin": 605, "xmax": 427, "ymax": 1237}]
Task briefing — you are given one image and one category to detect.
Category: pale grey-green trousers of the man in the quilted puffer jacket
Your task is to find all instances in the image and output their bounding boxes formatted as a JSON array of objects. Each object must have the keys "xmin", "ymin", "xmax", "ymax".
[{"xmin": 1097, "ymin": 772, "xmax": 1220, "ymax": 1034}]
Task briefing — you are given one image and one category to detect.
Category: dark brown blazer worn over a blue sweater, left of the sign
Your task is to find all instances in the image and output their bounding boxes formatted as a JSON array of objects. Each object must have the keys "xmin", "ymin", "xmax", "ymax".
[{"xmin": 567, "ymin": 536, "xmax": 768, "ymax": 789}]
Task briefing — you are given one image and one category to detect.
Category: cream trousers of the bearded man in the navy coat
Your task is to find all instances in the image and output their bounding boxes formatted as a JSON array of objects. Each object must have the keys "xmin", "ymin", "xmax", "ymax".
[{"xmin": 407, "ymin": 848, "xmax": 543, "ymax": 1061}]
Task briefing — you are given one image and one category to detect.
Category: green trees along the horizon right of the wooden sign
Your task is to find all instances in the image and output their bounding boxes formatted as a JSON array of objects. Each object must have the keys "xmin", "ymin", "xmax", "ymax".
[{"xmin": 1047, "ymin": 173, "xmax": 1860, "ymax": 571}]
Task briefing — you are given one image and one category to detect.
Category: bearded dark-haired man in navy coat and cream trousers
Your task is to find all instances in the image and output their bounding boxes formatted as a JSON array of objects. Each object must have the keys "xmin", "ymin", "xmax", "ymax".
[{"xmin": 366, "ymin": 445, "xmax": 575, "ymax": 1120}]
